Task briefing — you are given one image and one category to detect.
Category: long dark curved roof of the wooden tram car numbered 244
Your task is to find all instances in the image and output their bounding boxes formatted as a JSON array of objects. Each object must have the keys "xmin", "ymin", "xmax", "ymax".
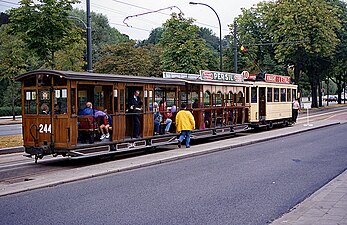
[{"xmin": 15, "ymin": 70, "xmax": 185, "ymax": 85}]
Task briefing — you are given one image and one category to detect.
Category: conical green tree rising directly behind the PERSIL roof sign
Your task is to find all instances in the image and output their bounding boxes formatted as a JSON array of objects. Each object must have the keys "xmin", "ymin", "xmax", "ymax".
[{"xmin": 159, "ymin": 13, "xmax": 210, "ymax": 73}]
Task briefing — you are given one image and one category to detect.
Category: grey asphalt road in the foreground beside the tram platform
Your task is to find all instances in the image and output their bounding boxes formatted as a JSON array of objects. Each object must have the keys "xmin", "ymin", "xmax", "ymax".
[{"xmin": 0, "ymin": 124, "xmax": 347, "ymax": 225}]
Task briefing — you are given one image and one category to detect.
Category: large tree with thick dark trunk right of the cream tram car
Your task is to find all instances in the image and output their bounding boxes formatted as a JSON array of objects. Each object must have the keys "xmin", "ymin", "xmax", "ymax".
[{"xmin": 266, "ymin": 0, "xmax": 341, "ymax": 107}]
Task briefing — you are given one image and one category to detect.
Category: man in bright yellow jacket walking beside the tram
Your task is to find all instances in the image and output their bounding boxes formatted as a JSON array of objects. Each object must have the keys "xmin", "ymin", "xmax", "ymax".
[{"xmin": 176, "ymin": 103, "xmax": 195, "ymax": 148}]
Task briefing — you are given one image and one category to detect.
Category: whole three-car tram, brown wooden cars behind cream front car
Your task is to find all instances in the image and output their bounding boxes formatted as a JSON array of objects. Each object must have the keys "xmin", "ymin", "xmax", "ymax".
[{"xmin": 16, "ymin": 70, "xmax": 297, "ymax": 162}]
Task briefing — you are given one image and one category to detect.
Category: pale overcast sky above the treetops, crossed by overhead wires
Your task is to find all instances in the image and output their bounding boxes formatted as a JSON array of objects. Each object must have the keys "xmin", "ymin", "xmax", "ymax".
[{"xmin": 0, "ymin": 0, "xmax": 261, "ymax": 40}]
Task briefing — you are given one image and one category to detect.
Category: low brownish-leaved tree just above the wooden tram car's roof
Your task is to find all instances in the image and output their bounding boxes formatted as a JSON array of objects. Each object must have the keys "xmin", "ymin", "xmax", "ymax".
[{"xmin": 95, "ymin": 41, "xmax": 162, "ymax": 77}]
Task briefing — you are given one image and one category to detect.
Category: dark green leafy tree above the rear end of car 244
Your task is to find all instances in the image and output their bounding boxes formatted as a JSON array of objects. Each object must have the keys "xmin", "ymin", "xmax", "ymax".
[{"xmin": 10, "ymin": 0, "xmax": 80, "ymax": 69}]
